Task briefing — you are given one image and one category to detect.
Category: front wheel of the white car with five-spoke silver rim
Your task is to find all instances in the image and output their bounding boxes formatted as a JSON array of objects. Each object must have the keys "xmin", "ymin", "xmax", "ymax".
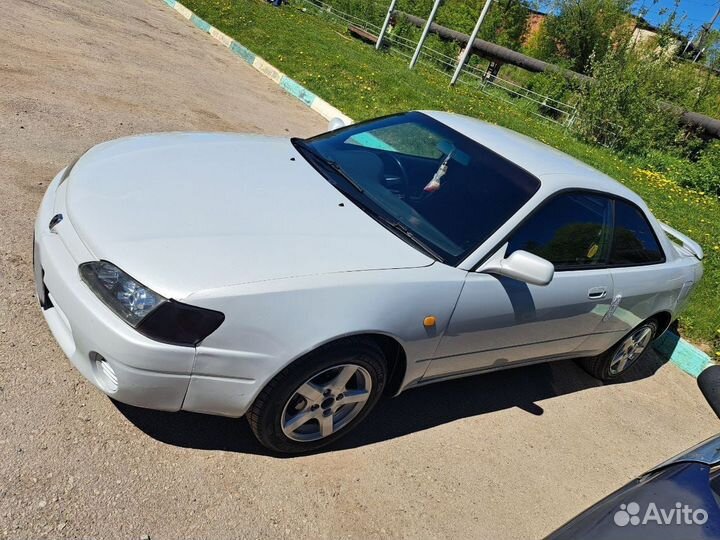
[{"xmin": 247, "ymin": 338, "xmax": 387, "ymax": 454}]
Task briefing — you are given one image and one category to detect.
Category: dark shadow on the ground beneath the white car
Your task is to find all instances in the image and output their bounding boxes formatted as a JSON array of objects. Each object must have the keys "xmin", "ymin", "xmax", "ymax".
[{"xmin": 113, "ymin": 338, "xmax": 677, "ymax": 457}]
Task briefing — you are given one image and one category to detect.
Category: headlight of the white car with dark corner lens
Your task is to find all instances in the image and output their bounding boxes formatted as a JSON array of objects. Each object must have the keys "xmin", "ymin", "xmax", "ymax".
[{"xmin": 79, "ymin": 261, "xmax": 225, "ymax": 346}]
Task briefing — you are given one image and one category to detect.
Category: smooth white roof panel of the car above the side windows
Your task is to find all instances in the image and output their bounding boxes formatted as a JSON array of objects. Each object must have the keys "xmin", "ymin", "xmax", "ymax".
[{"xmin": 419, "ymin": 111, "xmax": 646, "ymax": 208}]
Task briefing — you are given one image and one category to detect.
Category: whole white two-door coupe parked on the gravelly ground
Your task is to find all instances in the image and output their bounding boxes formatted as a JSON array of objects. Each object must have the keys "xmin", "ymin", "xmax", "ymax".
[{"xmin": 35, "ymin": 112, "xmax": 702, "ymax": 452}]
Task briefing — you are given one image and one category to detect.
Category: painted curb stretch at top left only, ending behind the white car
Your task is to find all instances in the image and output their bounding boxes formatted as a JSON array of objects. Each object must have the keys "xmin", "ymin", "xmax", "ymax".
[{"xmin": 163, "ymin": 0, "xmax": 352, "ymax": 124}]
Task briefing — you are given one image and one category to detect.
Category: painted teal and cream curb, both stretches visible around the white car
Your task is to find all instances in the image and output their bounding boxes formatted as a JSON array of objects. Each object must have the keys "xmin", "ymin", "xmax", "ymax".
[{"xmin": 163, "ymin": 0, "xmax": 712, "ymax": 377}]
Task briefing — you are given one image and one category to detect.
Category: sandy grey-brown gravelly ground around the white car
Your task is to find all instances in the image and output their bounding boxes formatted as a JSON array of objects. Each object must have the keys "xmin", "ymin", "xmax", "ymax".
[{"xmin": 0, "ymin": 0, "xmax": 718, "ymax": 539}]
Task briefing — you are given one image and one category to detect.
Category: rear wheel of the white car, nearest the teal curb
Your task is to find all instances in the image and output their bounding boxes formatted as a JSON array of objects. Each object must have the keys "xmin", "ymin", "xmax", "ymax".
[{"xmin": 580, "ymin": 319, "xmax": 658, "ymax": 381}]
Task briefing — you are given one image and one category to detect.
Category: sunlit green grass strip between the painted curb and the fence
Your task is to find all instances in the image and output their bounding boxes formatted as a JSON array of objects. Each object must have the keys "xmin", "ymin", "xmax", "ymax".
[{"xmin": 183, "ymin": 0, "xmax": 720, "ymax": 352}]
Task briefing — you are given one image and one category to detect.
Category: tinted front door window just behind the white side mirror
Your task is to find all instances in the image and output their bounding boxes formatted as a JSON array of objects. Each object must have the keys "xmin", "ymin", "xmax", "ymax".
[{"xmin": 506, "ymin": 193, "xmax": 612, "ymax": 270}]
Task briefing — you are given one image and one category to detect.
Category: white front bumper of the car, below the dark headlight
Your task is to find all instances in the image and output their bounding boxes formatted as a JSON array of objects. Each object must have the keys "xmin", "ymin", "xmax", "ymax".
[{"xmin": 34, "ymin": 171, "xmax": 195, "ymax": 411}]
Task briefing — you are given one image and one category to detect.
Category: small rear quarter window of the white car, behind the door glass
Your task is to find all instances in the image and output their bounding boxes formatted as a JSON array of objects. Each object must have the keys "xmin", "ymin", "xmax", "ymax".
[{"xmin": 610, "ymin": 201, "xmax": 664, "ymax": 265}]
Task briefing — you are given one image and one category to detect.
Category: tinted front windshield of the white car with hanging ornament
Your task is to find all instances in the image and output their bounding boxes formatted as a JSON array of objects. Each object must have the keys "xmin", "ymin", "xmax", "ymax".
[{"xmin": 293, "ymin": 112, "xmax": 540, "ymax": 264}]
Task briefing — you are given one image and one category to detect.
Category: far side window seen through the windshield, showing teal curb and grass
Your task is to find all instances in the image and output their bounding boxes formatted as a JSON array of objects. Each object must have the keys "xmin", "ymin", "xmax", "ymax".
[{"xmin": 345, "ymin": 122, "xmax": 443, "ymax": 159}]
